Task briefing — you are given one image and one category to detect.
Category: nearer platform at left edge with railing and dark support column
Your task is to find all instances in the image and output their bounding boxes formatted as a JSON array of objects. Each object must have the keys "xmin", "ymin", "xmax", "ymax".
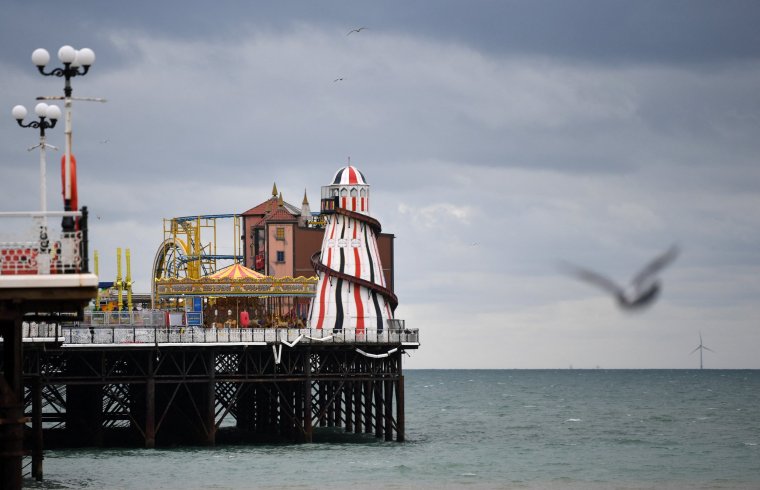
[{"xmin": 0, "ymin": 208, "xmax": 98, "ymax": 488}]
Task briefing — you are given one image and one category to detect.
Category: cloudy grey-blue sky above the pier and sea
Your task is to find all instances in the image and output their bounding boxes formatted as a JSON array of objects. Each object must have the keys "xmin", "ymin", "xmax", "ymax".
[{"xmin": 0, "ymin": 0, "xmax": 760, "ymax": 369}]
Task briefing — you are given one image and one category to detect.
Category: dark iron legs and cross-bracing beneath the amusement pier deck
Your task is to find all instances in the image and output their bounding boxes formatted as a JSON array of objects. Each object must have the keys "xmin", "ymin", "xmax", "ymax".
[{"xmin": 19, "ymin": 343, "xmax": 404, "ymax": 448}]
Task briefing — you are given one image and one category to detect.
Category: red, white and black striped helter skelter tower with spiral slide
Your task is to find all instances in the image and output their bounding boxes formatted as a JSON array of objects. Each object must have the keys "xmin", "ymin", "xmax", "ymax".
[{"xmin": 309, "ymin": 165, "xmax": 398, "ymax": 333}]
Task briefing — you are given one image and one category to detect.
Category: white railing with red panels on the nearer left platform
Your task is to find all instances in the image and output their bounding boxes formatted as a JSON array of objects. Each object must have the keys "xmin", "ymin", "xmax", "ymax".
[{"xmin": 0, "ymin": 208, "xmax": 87, "ymax": 276}]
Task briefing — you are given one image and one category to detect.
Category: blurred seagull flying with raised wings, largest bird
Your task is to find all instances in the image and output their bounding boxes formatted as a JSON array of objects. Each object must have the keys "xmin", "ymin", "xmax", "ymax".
[{"xmin": 565, "ymin": 245, "xmax": 679, "ymax": 310}]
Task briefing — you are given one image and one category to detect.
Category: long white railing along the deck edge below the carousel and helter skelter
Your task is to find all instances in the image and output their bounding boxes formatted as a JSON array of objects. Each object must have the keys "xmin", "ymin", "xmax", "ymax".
[{"xmin": 17, "ymin": 323, "xmax": 419, "ymax": 346}]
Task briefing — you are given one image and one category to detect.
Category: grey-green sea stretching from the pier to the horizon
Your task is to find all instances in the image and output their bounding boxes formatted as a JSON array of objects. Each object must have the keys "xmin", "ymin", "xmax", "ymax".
[{"xmin": 24, "ymin": 369, "xmax": 760, "ymax": 490}]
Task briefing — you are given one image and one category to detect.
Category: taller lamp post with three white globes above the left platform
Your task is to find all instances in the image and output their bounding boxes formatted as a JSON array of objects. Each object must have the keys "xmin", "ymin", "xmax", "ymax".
[{"xmin": 32, "ymin": 45, "xmax": 95, "ymax": 232}]
